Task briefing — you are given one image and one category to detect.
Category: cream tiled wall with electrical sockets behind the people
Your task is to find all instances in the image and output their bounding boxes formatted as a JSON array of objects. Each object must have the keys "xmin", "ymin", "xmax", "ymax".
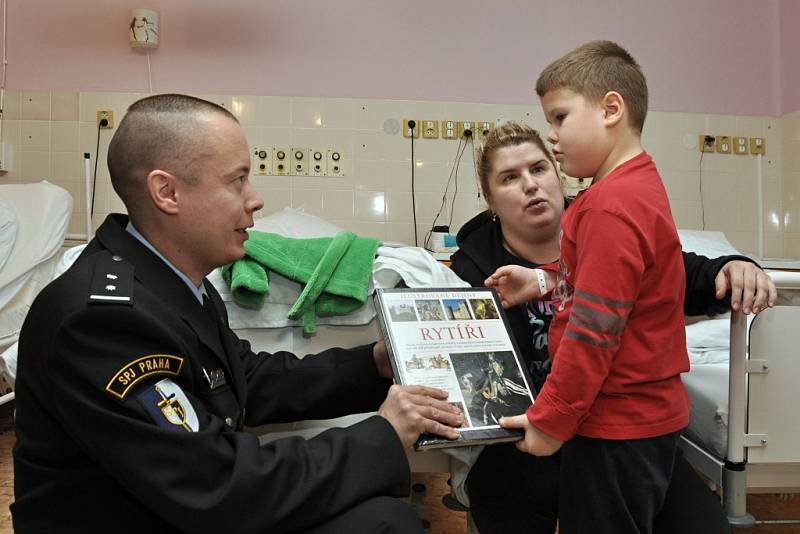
[{"xmin": 0, "ymin": 91, "xmax": 800, "ymax": 258}]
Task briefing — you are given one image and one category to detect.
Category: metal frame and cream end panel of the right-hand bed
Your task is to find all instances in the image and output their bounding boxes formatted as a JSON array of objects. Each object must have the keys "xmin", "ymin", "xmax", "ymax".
[{"xmin": 681, "ymin": 271, "xmax": 800, "ymax": 527}]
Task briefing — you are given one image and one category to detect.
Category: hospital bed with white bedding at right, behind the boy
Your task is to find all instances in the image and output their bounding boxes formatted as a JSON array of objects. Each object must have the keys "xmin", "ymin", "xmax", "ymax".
[{"xmin": 681, "ymin": 232, "xmax": 800, "ymax": 526}]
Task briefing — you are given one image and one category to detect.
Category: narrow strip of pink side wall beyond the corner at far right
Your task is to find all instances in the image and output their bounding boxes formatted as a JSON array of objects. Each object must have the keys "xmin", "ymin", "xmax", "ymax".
[{"xmin": 780, "ymin": 0, "xmax": 800, "ymax": 113}]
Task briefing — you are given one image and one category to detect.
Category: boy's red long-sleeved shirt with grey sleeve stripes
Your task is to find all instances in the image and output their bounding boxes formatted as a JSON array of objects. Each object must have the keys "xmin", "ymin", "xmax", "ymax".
[{"xmin": 528, "ymin": 152, "xmax": 689, "ymax": 440}]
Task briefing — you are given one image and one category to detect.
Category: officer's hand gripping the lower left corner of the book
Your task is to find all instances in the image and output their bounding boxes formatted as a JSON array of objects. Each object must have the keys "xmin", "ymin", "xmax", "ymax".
[{"xmin": 378, "ymin": 385, "xmax": 464, "ymax": 449}]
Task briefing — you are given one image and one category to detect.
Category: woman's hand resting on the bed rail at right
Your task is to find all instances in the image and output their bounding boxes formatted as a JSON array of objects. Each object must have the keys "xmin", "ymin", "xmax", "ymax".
[{"xmin": 714, "ymin": 260, "xmax": 778, "ymax": 313}]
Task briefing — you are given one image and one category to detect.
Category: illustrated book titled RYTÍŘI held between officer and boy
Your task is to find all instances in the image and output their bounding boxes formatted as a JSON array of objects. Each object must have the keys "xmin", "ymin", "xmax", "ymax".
[{"xmin": 375, "ymin": 287, "xmax": 534, "ymax": 450}]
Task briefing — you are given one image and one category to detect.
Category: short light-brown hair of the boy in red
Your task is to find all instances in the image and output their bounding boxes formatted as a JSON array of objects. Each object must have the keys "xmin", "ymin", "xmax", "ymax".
[{"xmin": 536, "ymin": 41, "xmax": 647, "ymax": 134}]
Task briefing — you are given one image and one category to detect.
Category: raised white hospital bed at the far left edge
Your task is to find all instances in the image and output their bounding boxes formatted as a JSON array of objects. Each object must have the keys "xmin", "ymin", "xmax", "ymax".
[{"xmin": 0, "ymin": 182, "xmax": 72, "ymax": 404}]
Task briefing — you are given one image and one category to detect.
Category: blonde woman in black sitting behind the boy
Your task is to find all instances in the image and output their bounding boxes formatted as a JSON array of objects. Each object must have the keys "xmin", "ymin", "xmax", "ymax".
[{"xmin": 452, "ymin": 123, "xmax": 776, "ymax": 534}]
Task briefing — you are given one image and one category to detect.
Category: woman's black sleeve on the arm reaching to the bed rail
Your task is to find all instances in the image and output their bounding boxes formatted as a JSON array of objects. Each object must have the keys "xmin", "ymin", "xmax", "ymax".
[{"xmin": 683, "ymin": 252, "xmax": 758, "ymax": 315}]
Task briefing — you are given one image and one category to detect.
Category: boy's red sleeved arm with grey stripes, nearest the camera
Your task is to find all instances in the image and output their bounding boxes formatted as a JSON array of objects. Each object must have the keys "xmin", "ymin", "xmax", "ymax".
[{"xmin": 528, "ymin": 210, "xmax": 652, "ymax": 441}]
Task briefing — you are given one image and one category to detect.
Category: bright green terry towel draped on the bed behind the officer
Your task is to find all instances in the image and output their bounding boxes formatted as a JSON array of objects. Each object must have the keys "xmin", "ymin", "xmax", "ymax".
[{"xmin": 222, "ymin": 231, "xmax": 381, "ymax": 334}]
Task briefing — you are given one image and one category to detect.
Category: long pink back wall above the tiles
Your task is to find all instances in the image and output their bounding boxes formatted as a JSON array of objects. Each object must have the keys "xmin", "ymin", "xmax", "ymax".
[{"xmin": 0, "ymin": 0, "xmax": 788, "ymax": 115}]
